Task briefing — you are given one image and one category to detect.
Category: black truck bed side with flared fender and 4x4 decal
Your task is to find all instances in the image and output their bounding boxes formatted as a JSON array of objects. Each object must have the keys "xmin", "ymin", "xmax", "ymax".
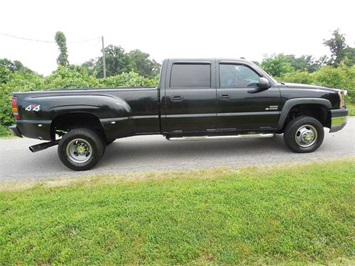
[{"xmin": 13, "ymin": 88, "xmax": 160, "ymax": 140}]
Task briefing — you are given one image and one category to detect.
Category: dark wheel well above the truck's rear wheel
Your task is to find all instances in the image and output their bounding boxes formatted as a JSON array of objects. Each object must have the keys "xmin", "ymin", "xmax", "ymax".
[{"xmin": 51, "ymin": 113, "xmax": 104, "ymax": 139}]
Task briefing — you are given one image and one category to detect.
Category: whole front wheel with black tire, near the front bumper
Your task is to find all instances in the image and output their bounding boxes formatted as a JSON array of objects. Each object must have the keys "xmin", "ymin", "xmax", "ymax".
[{"xmin": 284, "ymin": 116, "xmax": 324, "ymax": 153}]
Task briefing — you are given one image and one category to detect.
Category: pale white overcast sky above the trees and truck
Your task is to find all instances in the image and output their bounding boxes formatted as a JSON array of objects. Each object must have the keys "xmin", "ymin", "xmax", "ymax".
[{"xmin": 0, "ymin": 0, "xmax": 355, "ymax": 75}]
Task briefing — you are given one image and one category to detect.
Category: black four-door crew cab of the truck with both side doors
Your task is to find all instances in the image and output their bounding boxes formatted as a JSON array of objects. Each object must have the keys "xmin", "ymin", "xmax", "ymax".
[{"xmin": 160, "ymin": 59, "xmax": 282, "ymax": 136}]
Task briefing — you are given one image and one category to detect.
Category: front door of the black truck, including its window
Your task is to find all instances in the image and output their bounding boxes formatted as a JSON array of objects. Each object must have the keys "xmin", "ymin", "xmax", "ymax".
[{"xmin": 217, "ymin": 63, "xmax": 280, "ymax": 132}]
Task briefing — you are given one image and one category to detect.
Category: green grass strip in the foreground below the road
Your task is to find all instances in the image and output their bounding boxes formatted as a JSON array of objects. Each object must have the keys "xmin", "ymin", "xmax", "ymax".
[{"xmin": 0, "ymin": 158, "xmax": 355, "ymax": 265}]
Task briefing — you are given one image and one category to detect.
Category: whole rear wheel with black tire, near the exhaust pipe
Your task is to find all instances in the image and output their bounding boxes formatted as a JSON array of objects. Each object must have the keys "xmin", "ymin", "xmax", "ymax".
[{"xmin": 58, "ymin": 128, "xmax": 105, "ymax": 171}]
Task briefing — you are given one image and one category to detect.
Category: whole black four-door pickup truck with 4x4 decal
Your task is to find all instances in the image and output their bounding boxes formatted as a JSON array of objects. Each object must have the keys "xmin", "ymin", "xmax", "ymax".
[{"xmin": 10, "ymin": 59, "xmax": 348, "ymax": 170}]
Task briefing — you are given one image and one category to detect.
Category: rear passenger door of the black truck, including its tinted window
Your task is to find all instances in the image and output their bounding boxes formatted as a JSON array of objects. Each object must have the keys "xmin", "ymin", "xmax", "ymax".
[{"xmin": 162, "ymin": 62, "xmax": 217, "ymax": 135}]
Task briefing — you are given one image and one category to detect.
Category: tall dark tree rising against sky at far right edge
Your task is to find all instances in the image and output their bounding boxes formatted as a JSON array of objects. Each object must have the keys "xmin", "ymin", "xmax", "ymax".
[{"xmin": 323, "ymin": 29, "xmax": 355, "ymax": 67}]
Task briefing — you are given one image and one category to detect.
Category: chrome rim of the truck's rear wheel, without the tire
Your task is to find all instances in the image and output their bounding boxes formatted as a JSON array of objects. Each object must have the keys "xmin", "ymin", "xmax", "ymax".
[{"xmin": 66, "ymin": 139, "xmax": 92, "ymax": 163}]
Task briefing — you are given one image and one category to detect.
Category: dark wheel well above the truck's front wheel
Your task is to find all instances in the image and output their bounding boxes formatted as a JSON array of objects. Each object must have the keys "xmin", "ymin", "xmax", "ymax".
[{"xmin": 284, "ymin": 104, "xmax": 330, "ymax": 127}]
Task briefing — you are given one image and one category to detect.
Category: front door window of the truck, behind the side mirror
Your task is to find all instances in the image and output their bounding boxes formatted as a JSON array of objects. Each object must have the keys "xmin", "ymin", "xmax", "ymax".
[{"xmin": 219, "ymin": 64, "xmax": 260, "ymax": 88}]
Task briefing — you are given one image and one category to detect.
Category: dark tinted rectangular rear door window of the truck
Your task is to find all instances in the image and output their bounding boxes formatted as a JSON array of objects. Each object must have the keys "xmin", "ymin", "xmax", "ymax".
[{"xmin": 170, "ymin": 64, "xmax": 211, "ymax": 88}]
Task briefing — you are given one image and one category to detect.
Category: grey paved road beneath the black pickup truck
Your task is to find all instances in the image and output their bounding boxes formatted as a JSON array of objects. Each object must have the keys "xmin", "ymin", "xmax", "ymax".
[{"xmin": 0, "ymin": 118, "xmax": 355, "ymax": 182}]
